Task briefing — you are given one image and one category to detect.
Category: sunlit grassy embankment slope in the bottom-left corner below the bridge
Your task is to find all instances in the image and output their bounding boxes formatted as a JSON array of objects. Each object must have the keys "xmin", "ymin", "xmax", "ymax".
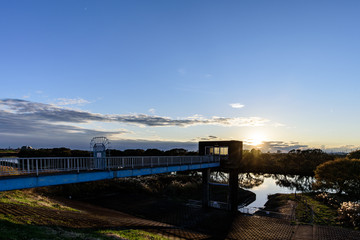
[{"xmin": 0, "ymin": 190, "xmax": 169, "ymax": 240}]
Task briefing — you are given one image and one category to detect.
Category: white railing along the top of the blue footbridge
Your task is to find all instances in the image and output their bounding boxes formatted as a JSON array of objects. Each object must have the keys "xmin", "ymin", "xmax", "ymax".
[{"xmin": 0, "ymin": 155, "xmax": 220, "ymax": 176}]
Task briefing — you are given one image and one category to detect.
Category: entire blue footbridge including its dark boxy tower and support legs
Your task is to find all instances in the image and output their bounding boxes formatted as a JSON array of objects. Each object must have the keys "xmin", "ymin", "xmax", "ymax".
[{"xmin": 0, "ymin": 141, "xmax": 242, "ymax": 211}]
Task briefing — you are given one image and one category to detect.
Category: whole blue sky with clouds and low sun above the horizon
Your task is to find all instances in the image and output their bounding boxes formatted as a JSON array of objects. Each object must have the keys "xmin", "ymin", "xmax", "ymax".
[{"xmin": 0, "ymin": 0, "xmax": 360, "ymax": 151}]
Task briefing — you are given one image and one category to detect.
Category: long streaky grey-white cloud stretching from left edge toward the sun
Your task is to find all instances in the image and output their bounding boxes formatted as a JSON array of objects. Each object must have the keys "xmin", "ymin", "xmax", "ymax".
[{"xmin": 0, "ymin": 99, "xmax": 276, "ymax": 127}]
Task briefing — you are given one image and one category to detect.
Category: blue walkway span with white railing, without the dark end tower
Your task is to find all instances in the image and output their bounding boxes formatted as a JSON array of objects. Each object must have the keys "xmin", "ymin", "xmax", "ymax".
[{"xmin": 0, "ymin": 156, "xmax": 220, "ymax": 191}]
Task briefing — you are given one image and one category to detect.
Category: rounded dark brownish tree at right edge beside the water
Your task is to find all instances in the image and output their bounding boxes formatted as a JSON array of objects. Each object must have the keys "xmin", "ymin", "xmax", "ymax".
[{"xmin": 314, "ymin": 158, "xmax": 360, "ymax": 197}]
